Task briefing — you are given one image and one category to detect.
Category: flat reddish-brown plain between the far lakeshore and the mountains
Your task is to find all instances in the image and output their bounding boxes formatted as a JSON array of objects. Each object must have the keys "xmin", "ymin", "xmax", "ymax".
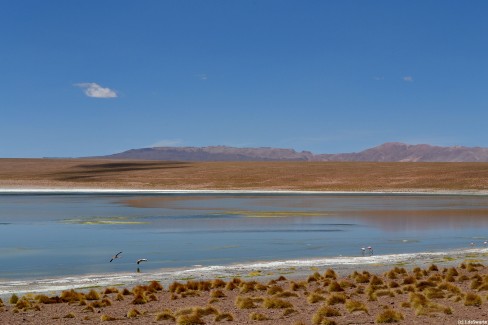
[{"xmin": 0, "ymin": 159, "xmax": 488, "ymax": 192}]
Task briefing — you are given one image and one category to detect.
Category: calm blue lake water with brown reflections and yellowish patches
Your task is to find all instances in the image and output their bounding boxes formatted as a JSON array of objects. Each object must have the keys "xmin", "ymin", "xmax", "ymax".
[{"xmin": 0, "ymin": 194, "xmax": 488, "ymax": 279}]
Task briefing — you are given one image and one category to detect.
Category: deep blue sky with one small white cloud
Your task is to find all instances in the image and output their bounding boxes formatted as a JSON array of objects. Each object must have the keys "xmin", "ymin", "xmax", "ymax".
[{"xmin": 0, "ymin": 0, "xmax": 488, "ymax": 157}]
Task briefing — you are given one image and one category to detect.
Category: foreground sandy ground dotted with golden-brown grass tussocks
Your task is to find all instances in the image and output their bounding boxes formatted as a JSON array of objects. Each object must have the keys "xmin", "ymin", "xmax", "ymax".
[{"xmin": 0, "ymin": 260, "xmax": 488, "ymax": 325}]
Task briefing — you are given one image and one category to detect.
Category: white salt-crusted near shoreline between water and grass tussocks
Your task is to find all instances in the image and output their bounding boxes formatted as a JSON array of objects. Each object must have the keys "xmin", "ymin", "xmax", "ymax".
[{"xmin": 0, "ymin": 247, "xmax": 488, "ymax": 299}]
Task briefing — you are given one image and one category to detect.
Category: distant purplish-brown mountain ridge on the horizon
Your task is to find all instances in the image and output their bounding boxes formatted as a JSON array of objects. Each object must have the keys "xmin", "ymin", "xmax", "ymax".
[{"xmin": 90, "ymin": 142, "xmax": 488, "ymax": 162}]
